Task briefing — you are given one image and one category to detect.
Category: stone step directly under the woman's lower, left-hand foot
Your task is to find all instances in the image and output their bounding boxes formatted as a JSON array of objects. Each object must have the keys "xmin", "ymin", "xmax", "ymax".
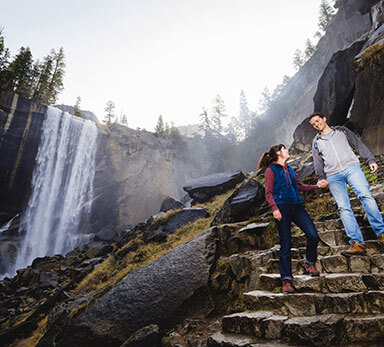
[{"xmin": 244, "ymin": 290, "xmax": 384, "ymax": 316}]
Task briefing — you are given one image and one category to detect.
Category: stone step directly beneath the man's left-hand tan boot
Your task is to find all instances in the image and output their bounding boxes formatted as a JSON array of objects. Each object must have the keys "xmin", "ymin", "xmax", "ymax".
[{"xmin": 261, "ymin": 251, "xmax": 384, "ymax": 275}]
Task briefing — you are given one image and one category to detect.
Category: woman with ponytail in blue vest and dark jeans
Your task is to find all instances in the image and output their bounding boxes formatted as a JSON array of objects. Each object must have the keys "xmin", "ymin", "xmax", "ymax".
[{"xmin": 259, "ymin": 144, "xmax": 322, "ymax": 293}]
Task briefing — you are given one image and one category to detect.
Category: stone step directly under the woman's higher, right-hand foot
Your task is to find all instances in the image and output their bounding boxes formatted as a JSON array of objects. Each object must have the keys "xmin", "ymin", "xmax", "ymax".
[{"xmin": 259, "ymin": 273, "xmax": 384, "ymax": 293}]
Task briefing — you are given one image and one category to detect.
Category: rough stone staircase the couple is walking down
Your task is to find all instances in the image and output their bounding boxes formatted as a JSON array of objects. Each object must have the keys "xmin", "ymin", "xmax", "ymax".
[{"xmin": 207, "ymin": 164, "xmax": 384, "ymax": 347}]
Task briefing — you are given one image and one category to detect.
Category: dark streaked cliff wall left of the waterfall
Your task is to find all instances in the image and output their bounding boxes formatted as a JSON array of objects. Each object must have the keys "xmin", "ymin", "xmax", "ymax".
[{"xmin": 0, "ymin": 91, "xmax": 46, "ymax": 224}]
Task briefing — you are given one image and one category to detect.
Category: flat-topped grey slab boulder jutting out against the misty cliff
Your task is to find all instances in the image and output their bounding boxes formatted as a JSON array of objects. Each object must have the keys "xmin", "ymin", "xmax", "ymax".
[{"xmin": 183, "ymin": 171, "xmax": 245, "ymax": 203}]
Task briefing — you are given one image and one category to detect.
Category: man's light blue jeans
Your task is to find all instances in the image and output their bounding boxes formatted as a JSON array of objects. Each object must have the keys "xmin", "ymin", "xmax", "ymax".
[{"xmin": 327, "ymin": 165, "xmax": 384, "ymax": 244}]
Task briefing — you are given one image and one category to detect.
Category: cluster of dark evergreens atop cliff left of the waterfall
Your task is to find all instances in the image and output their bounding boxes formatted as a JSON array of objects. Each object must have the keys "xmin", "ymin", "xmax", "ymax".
[{"xmin": 0, "ymin": 28, "xmax": 65, "ymax": 105}]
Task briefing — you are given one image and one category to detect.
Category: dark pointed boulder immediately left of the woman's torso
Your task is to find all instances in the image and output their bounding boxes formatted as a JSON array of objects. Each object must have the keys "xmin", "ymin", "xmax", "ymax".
[{"xmin": 212, "ymin": 179, "xmax": 265, "ymax": 225}]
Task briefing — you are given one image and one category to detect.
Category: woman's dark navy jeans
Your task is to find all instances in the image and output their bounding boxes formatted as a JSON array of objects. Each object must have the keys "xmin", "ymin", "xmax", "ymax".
[{"xmin": 275, "ymin": 204, "xmax": 319, "ymax": 280}]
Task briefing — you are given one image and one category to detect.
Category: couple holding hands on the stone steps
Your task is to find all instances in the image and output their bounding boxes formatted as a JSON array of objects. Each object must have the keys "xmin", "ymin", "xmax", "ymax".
[{"xmin": 259, "ymin": 113, "xmax": 384, "ymax": 293}]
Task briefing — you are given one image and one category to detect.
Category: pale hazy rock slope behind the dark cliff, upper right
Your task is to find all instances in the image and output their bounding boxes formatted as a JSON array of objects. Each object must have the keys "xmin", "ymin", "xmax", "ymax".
[{"xmin": 269, "ymin": 0, "xmax": 377, "ymax": 145}]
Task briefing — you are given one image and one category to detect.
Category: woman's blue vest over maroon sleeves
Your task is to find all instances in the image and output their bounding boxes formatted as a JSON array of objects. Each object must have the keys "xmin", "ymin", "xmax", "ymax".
[{"xmin": 269, "ymin": 164, "xmax": 303, "ymax": 205}]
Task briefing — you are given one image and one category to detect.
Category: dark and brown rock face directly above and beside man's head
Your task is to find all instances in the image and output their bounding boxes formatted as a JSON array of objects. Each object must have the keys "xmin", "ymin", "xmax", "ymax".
[{"xmin": 292, "ymin": 1, "xmax": 384, "ymax": 154}]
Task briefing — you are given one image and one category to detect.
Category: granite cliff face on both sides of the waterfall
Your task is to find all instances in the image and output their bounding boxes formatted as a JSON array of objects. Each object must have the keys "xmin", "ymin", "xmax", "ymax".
[{"xmin": 0, "ymin": 91, "xmax": 209, "ymax": 232}]
